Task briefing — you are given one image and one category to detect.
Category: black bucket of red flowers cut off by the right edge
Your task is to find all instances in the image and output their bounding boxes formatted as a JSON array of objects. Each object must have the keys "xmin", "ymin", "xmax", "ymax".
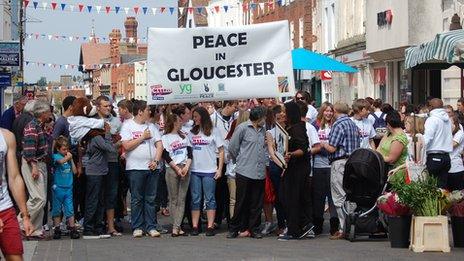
[{"xmin": 448, "ymin": 190, "xmax": 464, "ymax": 247}]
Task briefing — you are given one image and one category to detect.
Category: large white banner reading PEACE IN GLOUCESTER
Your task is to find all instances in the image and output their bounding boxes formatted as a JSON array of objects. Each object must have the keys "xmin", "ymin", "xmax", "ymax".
[{"xmin": 147, "ymin": 21, "xmax": 295, "ymax": 104}]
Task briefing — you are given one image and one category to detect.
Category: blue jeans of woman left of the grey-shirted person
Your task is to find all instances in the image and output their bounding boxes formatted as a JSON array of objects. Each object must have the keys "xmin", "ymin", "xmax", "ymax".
[{"xmin": 190, "ymin": 172, "xmax": 216, "ymax": 210}]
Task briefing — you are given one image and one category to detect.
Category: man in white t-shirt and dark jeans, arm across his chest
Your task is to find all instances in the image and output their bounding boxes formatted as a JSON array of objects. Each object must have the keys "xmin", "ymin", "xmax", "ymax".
[{"xmin": 121, "ymin": 100, "xmax": 163, "ymax": 237}]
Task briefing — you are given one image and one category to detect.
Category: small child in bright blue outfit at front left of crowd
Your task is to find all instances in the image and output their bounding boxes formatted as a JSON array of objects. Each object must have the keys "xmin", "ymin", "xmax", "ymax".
[{"xmin": 52, "ymin": 136, "xmax": 80, "ymax": 239}]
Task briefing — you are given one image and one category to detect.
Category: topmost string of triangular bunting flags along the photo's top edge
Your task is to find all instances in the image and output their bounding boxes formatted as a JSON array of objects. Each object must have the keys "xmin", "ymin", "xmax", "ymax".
[{"xmin": 23, "ymin": 0, "xmax": 285, "ymax": 15}]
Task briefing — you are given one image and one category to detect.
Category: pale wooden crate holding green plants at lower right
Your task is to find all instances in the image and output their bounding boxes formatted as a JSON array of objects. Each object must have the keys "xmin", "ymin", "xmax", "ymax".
[{"xmin": 409, "ymin": 213, "xmax": 450, "ymax": 252}]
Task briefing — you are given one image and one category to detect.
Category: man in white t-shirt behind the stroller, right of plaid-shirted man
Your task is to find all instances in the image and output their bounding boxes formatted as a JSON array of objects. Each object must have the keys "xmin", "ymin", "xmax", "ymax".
[{"xmin": 351, "ymin": 99, "xmax": 376, "ymax": 149}]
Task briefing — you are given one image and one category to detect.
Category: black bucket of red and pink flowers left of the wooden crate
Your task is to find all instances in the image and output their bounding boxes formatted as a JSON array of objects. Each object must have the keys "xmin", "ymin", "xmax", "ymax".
[{"xmin": 377, "ymin": 192, "xmax": 411, "ymax": 248}]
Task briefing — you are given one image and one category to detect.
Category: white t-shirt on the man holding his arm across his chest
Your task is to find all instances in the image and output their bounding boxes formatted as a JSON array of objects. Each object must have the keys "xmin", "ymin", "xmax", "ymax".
[{"xmin": 121, "ymin": 120, "xmax": 161, "ymax": 170}]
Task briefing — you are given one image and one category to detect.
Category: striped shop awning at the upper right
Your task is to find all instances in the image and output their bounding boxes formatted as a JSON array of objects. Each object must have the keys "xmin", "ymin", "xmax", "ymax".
[{"xmin": 405, "ymin": 29, "xmax": 464, "ymax": 69}]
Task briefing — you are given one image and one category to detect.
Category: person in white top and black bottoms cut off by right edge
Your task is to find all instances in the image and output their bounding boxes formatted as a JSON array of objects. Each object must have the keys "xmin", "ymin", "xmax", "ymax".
[{"xmin": 448, "ymin": 115, "xmax": 464, "ymax": 191}]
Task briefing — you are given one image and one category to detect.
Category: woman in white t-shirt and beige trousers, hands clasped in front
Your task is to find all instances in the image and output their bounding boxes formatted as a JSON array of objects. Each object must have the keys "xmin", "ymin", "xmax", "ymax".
[{"xmin": 161, "ymin": 114, "xmax": 192, "ymax": 237}]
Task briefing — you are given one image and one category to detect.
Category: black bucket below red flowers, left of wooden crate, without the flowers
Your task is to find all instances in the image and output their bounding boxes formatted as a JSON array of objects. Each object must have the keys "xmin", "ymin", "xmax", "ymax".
[{"xmin": 388, "ymin": 215, "xmax": 412, "ymax": 248}]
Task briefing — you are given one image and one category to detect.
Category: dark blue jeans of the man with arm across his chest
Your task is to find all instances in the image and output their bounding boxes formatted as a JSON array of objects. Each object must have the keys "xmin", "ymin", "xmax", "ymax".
[{"xmin": 127, "ymin": 170, "xmax": 159, "ymax": 232}]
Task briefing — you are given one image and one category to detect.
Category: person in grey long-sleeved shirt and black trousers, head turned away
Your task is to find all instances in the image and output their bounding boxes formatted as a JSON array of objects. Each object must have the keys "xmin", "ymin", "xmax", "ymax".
[{"xmin": 227, "ymin": 107, "xmax": 266, "ymax": 238}]
